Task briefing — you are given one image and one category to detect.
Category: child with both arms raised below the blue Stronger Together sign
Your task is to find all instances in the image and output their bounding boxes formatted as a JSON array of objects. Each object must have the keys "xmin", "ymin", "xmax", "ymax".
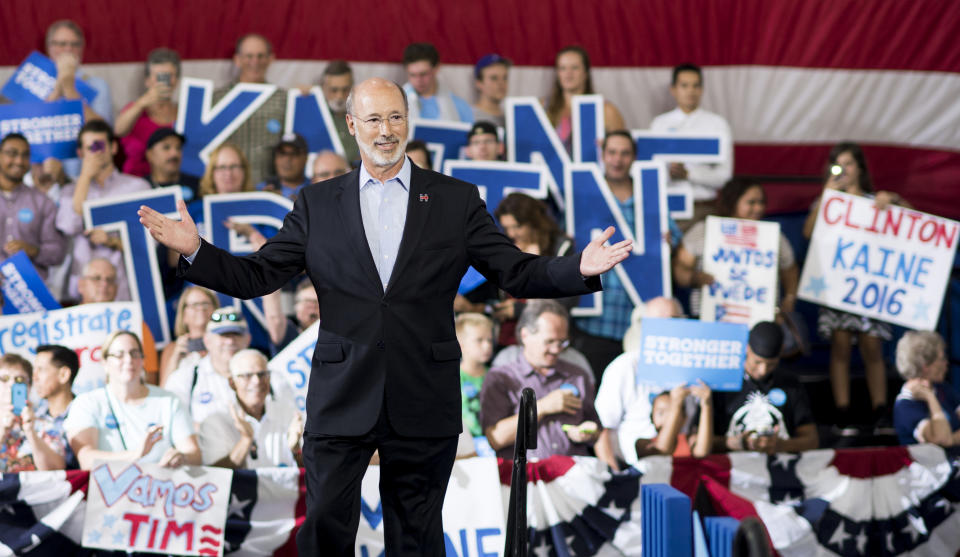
[{"xmin": 637, "ymin": 381, "xmax": 713, "ymax": 458}]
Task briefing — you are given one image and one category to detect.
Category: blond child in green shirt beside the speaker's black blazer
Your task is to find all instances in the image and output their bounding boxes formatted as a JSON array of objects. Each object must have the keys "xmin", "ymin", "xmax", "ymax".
[{"xmin": 456, "ymin": 313, "xmax": 493, "ymax": 437}]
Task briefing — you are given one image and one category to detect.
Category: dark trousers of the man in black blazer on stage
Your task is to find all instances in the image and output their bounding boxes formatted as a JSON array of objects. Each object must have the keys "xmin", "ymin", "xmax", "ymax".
[{"xmin": 297, "ymin": 407, "xmax": 457, "ymax": 557}]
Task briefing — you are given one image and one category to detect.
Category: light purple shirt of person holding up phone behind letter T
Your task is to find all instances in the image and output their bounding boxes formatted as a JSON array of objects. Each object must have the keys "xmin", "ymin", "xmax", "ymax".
[{"xmin": 57, "ymin": 169, "xmax": 150, "ymax": 301}]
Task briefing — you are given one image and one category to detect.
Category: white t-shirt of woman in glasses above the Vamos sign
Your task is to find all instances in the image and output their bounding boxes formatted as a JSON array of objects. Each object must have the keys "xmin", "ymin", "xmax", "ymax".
[{"xmin": 63, "ymin": 385, "xmax": 193, "ymax": 462}]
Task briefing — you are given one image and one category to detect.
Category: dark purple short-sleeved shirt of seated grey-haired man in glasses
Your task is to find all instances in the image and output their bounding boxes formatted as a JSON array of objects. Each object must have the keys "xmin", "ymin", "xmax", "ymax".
[{"xmin": 480, "ymin": 354, "xmax": 600, "ymax": 459}]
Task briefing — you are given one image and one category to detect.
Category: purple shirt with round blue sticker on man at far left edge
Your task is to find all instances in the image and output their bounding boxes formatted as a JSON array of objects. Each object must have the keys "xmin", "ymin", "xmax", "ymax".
[{"xmin": 0, "ymin": 184, "xmax": 67, "ymax": 278}]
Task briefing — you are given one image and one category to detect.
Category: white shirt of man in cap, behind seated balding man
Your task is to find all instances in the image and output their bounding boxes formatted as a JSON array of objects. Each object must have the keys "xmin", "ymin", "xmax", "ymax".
[{"xmin": 163, "ymin": 355, "xmax": 297, "ymax": 427}]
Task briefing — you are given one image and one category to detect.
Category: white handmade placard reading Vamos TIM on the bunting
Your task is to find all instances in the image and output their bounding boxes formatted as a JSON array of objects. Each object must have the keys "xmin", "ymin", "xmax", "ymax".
[{"xmin": 82, "ymin": 462, "xmax": 233, "ymax": 556}]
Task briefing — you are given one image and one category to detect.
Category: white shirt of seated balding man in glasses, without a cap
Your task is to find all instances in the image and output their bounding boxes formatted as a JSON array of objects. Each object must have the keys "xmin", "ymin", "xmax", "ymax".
[{"xmin": 200, "ymin": 395, "xmax": 297, "ymax": 468}]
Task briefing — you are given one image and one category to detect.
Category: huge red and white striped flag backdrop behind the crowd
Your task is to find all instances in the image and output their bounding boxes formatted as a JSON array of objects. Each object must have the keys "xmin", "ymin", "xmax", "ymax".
[{"xmin": 0, "ymin": 0, "xmax": 960, "ymax": 218}]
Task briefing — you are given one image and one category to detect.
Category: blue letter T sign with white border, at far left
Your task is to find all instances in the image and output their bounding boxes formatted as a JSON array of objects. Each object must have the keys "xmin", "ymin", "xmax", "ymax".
[{"xmin": 83, "ymin": 186, "xmax": 181, "ymax": 346}]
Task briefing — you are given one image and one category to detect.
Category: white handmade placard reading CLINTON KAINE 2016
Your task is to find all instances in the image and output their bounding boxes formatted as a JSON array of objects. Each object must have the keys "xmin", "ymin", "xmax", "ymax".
[{"xmin": 797, "ymin": 190, "xmax": 960, "ymax": 330}]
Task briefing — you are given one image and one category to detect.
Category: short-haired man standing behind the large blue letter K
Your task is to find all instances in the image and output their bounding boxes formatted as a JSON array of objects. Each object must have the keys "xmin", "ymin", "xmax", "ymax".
[{"xmin": 213, "ymin": 33, "xmax": 287, "ymax": 184}]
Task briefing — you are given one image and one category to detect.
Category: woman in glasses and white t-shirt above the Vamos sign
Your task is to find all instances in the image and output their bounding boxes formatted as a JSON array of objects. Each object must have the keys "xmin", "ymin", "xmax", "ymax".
[{"xmin": 63, "ymin": 330, "xmax": 201, "ymax": 470}]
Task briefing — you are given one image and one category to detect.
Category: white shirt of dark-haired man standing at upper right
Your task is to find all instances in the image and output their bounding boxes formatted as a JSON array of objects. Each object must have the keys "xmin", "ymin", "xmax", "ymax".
[{"xmin": 650, "ymin": 108, "xmax": 733, "ymax": 201}]
